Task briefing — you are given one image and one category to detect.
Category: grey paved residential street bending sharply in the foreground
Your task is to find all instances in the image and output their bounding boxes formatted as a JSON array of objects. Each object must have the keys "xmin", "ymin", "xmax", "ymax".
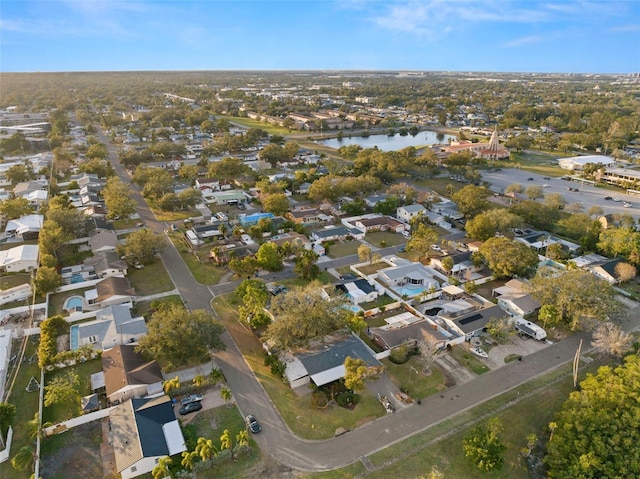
[{"xmin": 100, "ymin": 130, "xmax": 640, "ymax": 471}]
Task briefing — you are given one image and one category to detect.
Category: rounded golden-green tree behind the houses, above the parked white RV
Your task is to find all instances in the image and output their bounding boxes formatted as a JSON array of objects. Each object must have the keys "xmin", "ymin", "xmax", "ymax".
[{"xmin": 479, "ymin": 238, "xmax": 538, "ymax": 278}]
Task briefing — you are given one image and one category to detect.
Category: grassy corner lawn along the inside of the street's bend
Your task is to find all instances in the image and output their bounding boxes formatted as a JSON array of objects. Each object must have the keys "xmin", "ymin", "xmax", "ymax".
[{"xmin": 213, "ymin": 294, "xmax": 385, "ymax": 439}]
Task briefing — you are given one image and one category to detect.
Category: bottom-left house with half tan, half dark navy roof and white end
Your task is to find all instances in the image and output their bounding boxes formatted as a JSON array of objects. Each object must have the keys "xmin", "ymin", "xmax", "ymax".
[{"xmin": 109, "ymin": 396, "xmax": 187, "ymax": 479}]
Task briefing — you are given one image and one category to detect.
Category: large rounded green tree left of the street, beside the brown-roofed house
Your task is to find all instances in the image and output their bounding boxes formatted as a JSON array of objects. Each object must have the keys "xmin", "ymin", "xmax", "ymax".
[{"xmin": 137, "ymin": 304, "xmax": 225, "ymax": 368}]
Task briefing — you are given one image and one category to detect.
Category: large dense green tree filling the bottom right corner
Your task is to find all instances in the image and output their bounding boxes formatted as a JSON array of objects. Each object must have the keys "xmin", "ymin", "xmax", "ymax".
[{"xmin": 545, "ymin": 354, "xmax": 640, "ymax": 479}]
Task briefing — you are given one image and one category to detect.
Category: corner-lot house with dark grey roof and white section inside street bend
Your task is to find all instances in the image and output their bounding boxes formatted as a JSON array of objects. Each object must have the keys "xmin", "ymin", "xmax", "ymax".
[{"xmin": 281, "ymin": 333, "xmax": 381, "ymax": 388}]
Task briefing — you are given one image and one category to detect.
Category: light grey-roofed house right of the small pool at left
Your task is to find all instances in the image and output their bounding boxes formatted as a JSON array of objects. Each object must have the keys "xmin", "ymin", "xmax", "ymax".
[{"xmin": 71, "ymin": 304, "xmax": 148, "ymax": 350}]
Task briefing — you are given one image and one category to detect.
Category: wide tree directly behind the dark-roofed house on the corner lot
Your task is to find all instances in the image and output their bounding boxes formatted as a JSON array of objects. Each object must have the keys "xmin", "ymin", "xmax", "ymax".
[{"xmin": 265, "ymin": 282, "xmax": 352, "ymax": 349}]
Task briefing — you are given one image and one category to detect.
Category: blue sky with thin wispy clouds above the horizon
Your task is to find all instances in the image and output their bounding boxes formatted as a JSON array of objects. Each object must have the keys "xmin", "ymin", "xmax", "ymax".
[{"xmin": 0, "ymin": 0, "xmax": 640, "ymax": 73}]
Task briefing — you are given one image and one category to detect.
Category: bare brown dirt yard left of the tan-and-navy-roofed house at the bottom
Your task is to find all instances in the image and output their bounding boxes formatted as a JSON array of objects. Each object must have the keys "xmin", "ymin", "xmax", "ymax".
[{"xmin": 40, "ymin": 421, "xmax": 103, "ymax": 479}]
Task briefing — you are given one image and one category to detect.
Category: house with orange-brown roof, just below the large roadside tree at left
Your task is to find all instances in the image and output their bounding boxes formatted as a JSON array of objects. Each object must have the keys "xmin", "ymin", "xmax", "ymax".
[{"xmin": 102, "ymin": 344, "xmax": 163, "ymax": 404}]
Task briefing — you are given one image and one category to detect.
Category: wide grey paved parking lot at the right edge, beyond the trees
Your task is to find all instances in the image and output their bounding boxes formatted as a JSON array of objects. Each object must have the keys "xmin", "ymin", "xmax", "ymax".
[{"xmin": 482, "ymin": 168, "xmax": 640, "ymax": 221}]
